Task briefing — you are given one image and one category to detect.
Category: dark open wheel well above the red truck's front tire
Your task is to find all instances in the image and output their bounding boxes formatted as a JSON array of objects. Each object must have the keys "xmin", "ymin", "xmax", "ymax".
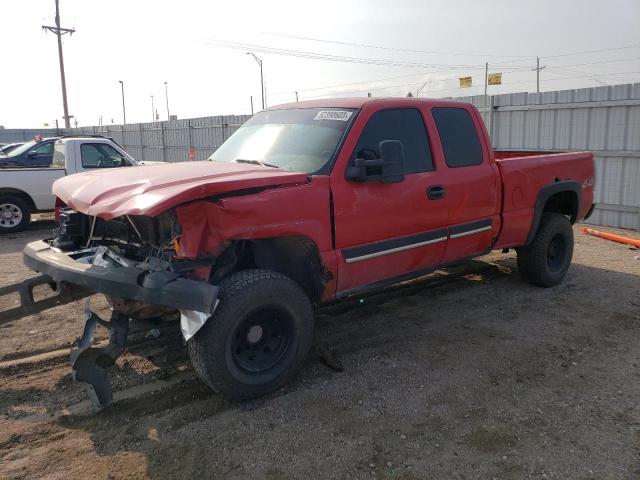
[{"xmin": 211, "ymin": 236, "xmax": 327, "ymax": 302}]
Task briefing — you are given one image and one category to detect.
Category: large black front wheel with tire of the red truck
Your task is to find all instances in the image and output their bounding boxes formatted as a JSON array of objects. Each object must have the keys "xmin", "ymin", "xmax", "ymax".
[{"xmin": 187, "ymin": 269, "xmax": 313, "ymax": 400}]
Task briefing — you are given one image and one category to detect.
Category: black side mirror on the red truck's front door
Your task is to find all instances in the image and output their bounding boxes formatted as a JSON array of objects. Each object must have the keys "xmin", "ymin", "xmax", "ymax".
[{"xmin": 345, "ymin": 140, "xmax": 404, "ymax": 183}]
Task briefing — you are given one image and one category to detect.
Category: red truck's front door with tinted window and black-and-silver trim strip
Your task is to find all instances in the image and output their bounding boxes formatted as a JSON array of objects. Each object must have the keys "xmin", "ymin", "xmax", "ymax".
[{"xmin": 331, "ymin": 108, "xmax": 448, "ymax": 294}]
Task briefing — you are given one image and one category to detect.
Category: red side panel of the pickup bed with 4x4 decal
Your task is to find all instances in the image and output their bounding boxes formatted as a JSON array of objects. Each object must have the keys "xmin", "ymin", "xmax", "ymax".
[{"xmin": 495, "ymin": 151, "xmax": 594, "ymax": 248}]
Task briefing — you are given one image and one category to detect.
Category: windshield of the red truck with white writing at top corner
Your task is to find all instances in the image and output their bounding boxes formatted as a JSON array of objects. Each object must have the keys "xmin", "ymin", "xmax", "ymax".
[{"xmin": 209, "ymin": 108, "xmax": 355, "ymax": 173}]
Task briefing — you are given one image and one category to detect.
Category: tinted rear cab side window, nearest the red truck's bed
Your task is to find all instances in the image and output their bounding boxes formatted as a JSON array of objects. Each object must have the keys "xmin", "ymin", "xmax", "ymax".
[{"xmin": 431, "ymin": 107, "xmax": 483, "ymax": 168}]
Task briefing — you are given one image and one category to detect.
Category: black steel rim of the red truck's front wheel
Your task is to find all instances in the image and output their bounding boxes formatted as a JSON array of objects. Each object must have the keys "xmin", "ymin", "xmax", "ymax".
[{"xmin": 231, "ymin": 306, "xmax": 293, "ymax": 374}]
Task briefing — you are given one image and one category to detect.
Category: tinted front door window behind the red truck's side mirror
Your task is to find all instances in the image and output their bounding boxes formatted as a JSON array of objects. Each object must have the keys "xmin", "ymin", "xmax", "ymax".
[{"xmin": 351, "ymin": 108, "xmax": 434, "ymax": 174}]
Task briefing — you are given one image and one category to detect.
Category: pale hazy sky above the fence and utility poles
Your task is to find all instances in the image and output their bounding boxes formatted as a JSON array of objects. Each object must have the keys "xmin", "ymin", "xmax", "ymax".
[{"xmin": 0, "ymin": 0, "xmax": 640, "ymax": 128}]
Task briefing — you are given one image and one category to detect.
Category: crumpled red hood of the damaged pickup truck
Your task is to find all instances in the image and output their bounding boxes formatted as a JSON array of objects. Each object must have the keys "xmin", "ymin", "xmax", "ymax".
[{"xmin": 53, "ymin": 161, "xmax": 308, "ymax": 220}]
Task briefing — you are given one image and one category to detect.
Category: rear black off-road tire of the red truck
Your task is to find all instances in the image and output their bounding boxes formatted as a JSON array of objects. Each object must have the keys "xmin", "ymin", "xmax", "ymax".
[{"xmin": 516, "ymin": 213, "xmax": 573, "ymax": 287}]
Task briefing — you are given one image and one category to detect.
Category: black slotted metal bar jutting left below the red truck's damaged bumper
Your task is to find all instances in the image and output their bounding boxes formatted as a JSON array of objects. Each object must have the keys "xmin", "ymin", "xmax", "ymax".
[{"xmin": 0, "ymin": 275, "xmax": 91, "ymax": 325}]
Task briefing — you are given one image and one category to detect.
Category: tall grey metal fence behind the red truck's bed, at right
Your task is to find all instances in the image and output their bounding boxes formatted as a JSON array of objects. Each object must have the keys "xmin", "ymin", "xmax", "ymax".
[{"xmin": 461, "ymin": 83, "xmax": 640, "ymax": 230}]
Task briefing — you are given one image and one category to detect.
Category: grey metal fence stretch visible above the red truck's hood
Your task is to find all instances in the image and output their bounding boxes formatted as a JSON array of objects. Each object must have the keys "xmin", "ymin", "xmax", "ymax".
[{"xmin": 68, "ymin": 115, "xmax": 251, "ymax": 162}]
